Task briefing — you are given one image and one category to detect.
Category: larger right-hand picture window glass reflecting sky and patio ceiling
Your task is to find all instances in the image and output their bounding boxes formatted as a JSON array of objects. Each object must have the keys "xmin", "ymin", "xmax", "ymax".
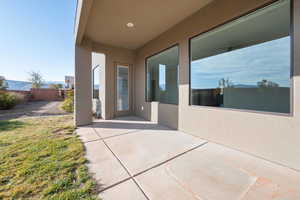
[{"xmin": 190, "ymin": 0, "xmax": 291, "ymax": 113}]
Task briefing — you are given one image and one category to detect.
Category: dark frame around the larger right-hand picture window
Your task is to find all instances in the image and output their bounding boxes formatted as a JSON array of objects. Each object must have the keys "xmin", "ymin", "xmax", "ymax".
[{"xmin": 188, "ymin": 0, "xmax": 295, "ymax": 117}]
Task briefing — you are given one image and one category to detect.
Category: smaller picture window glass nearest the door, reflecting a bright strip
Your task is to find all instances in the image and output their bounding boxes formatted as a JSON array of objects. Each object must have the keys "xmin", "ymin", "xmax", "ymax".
[{"xmin": 146, "ymin": 46, "xmax": 178, "ymax": 104}]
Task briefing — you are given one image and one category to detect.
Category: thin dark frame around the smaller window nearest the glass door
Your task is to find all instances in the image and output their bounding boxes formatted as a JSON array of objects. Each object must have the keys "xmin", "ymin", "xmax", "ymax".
[{"xmin": 145, "ymin": 43, "xmax": 180, "ymax": 106}]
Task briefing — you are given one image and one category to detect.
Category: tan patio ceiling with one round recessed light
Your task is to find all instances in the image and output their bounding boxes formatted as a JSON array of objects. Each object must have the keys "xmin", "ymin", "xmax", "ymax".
[{"xmin": 75, "ymin": 0, "xmax": 213, "ymax": 49}]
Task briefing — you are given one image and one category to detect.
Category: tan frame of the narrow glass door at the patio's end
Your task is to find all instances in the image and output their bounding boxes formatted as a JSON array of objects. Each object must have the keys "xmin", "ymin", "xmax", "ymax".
[{"xmin": 114, "ymin": 62, "xmax": 133, "ymax": 117}]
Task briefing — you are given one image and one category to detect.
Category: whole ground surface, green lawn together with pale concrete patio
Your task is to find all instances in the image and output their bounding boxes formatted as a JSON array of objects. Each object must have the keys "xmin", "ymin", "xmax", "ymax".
[{"xmin": 0, "ymin": 111, "xmax": 300, "ymax": 200}]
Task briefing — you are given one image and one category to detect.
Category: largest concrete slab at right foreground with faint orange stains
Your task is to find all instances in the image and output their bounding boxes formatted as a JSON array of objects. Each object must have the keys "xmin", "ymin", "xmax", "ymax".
[{"xmin": 136, "ymin": 143, "xmax": 300, "ymax": 200}]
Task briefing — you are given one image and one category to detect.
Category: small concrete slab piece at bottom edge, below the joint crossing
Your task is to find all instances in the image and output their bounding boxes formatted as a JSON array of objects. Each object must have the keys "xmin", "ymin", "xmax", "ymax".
[{"xmin": 99, "ymin": 180, "xmax": 147, "ymax": 200}]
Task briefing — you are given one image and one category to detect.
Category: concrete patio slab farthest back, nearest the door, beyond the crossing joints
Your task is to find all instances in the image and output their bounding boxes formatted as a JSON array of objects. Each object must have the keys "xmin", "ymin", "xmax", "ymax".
[{"xmin": 105, "ymin": 129, "xmax": 206, "ymax": 175}]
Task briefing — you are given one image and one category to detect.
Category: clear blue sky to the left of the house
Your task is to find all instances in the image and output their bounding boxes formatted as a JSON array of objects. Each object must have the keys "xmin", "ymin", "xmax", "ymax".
[{"xmin": 0, "ymin": 0, "xmax": 76, "ymax": 81}]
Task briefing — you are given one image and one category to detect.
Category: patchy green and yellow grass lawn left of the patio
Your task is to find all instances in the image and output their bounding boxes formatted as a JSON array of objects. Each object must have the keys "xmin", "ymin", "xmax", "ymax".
[{"xmin": 0, "ymin": 116, "xmax": 96, "ymax": 200}]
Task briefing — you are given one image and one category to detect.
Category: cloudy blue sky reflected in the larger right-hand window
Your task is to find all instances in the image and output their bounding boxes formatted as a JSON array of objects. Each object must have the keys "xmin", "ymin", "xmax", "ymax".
[{"xmin": 191, "ymin": 37, "xmax": 290, "ymax": 89}]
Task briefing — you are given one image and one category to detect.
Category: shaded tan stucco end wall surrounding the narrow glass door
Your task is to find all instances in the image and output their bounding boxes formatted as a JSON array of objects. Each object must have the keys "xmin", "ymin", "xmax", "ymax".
[{"xmin": 92, "ymin": 43, "xmax": 135, "ymax": 119}]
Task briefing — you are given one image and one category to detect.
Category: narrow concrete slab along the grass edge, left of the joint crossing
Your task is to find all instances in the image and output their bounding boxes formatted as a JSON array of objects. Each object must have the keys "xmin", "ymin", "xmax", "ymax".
[{"xmin": 84, "ymin": 141, "xmax": 129, "ymax": 190}]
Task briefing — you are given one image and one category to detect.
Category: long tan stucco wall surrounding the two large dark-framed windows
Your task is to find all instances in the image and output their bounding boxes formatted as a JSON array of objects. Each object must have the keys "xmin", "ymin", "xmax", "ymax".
[{"xmin": 135, "ymin": 0, "xmax": 300, "ymax": 169}]
